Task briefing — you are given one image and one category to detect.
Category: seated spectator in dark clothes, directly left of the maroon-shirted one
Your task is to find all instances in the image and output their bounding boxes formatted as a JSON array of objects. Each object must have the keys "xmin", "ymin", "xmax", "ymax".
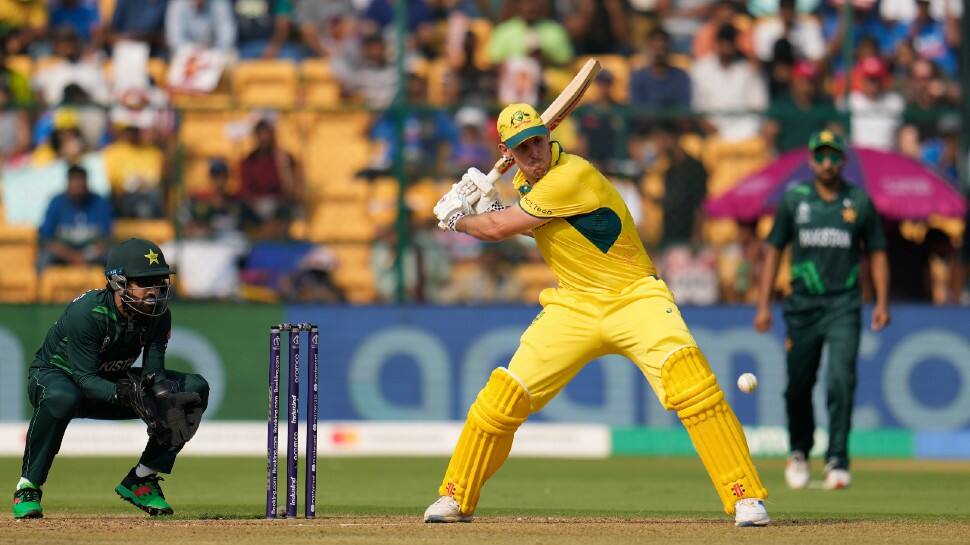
[{"xmin": 179, "ymin": 159, "xmax": 256, "ymax": 240}]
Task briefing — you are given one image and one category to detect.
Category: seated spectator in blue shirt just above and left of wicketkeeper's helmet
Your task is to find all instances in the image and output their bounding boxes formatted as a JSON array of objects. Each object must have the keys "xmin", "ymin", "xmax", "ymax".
[{"xmin": 38, "ymin": 166, "xmax": 112, "ymax": 269}]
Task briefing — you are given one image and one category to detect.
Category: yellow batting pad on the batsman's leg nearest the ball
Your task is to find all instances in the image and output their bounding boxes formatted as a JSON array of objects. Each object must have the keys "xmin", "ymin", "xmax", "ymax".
[{"xmin": 660, "ymin": 346, "xmax": 768, "ymax": 515}]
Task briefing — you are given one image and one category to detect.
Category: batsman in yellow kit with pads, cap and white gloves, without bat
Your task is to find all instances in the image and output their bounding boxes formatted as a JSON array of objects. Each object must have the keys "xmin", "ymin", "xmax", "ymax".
[{"xmin": 424, "ymin": 104, "xmax": 770, "ymax": 526}]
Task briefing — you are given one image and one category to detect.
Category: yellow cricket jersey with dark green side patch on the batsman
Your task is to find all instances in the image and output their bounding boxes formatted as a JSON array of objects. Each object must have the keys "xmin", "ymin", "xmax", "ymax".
[{"xmin": 512, "ymin": 142, "xmax": 656, "ymax": 293}]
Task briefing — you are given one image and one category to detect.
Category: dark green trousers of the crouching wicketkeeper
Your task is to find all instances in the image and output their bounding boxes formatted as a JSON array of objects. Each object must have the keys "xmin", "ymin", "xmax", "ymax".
[{"xmin": 21, "ymin": 368, "xmax": 209, "ymax": 486}]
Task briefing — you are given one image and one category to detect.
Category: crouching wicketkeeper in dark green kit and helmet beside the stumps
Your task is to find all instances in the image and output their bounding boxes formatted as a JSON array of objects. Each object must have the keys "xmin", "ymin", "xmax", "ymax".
[{"xmin": 13, "ymin": 238, "xmax": 209, "ymax": 519}]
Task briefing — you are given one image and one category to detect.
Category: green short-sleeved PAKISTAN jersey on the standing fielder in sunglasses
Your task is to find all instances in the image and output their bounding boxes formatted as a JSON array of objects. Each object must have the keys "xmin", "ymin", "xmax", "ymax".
[{"xmin": 768, "ymin": 181, "xmax": 886, "ymax": 304}]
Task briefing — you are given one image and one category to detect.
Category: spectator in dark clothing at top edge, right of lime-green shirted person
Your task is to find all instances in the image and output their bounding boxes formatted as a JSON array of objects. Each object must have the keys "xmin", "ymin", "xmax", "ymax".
[{"xmin": 556, "ymin": 0, "xmax": 631, "ymax": 56}]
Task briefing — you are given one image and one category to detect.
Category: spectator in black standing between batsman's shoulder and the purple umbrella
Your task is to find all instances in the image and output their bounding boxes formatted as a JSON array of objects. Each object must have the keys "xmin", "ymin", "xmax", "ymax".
[{"xmin": 652, "ymin": 123, "xmax": 707, "ymax": 247}]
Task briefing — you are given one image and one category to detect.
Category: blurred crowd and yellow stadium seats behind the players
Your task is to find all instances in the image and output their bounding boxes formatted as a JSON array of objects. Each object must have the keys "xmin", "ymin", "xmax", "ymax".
[{"xmin": 0, "ymin": 0, "xmax": 970, "ymax": 304}]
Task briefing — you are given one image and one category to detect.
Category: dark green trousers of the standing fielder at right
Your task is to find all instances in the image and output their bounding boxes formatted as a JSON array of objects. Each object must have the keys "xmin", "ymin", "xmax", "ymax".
[{"xmin": 785, "ymin": 305, "xmax": 862, "ymax": 469}]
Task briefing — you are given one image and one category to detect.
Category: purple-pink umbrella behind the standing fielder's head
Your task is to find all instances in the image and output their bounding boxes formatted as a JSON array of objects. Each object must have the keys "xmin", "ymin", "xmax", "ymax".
[{"xmin": 704, "ymin": 148, "xmax": 967, "ymax": 221}]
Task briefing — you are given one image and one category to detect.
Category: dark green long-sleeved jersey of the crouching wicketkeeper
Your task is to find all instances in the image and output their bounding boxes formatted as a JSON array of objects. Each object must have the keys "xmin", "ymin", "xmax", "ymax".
[{"xmin": 31, "ymin": 289, "xmax": 172, "ymax": 401}]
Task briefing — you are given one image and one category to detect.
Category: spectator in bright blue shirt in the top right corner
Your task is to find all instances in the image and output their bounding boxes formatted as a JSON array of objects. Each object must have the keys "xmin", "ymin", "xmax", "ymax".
[{"xmin": 890, "ymin": 0, "xmax": 960, "ymax": 77}]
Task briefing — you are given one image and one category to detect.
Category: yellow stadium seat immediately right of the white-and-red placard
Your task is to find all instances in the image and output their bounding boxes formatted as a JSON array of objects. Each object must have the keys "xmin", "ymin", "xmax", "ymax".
[{"xmin": 232, "ymin": 60, "xmax": 299, "ymax": 108}]
